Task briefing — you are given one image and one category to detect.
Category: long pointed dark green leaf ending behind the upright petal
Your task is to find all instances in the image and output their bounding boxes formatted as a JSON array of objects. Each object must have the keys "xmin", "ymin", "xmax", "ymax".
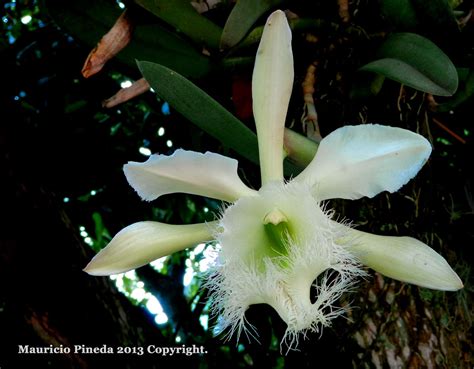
[{"xmin": 138, "ymin": 61, "xmax": 258, "ymax": 163}]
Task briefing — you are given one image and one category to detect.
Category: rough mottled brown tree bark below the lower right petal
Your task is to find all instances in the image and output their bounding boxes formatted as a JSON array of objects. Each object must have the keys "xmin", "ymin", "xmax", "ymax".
[{"xmin": 352, "ymin": 274, "xmax": 473, "ymax": 369}]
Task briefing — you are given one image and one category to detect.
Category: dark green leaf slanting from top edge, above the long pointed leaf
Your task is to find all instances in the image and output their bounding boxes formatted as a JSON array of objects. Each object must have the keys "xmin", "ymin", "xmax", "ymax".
[{"xmin": 135, "ymin": 0, "xmax": 222, "ymax": 49}]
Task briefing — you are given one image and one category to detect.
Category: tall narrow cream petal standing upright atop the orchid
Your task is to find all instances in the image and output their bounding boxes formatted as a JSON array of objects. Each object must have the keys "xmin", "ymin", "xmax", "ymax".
[{"xmin": 252, "ymin": 10, "xmax": 294, "ymax": 184}]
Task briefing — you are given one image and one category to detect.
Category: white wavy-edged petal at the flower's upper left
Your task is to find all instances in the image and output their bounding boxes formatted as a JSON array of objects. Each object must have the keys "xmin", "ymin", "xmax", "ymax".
[{"xmin": 123, "ymin": 149, "xmax": 256, "ymax": 202}]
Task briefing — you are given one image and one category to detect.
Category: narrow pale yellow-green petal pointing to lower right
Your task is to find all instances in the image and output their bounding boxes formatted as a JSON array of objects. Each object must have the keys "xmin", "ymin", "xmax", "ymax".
[{"xmin": 345, "ymin": 229, "xmax": 463, "ymax": 291}]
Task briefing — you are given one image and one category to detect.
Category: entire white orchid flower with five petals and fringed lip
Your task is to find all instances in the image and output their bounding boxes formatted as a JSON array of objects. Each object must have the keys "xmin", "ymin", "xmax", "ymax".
[{"xmin": 85, "ymin": 11, "xmax": 462, "ymax": 346}]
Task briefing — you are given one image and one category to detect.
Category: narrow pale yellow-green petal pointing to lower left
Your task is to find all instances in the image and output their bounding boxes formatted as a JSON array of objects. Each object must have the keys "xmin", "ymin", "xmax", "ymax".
[{"xmin": 84, "ymin": 221, "xmax": 217, "ymax": 275}]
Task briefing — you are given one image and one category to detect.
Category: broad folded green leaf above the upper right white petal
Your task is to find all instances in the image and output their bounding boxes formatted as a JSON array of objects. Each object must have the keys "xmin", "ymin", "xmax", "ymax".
[{"xmin": 360, "ymin": 33, "xmax": 458, "ymax": 96}]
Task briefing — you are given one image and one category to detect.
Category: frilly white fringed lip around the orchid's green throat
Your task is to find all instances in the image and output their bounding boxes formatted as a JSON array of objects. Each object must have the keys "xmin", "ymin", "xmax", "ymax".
[{"xmin": 206, "ymin": 183, "xmax": 364, "ymax": 348}]
